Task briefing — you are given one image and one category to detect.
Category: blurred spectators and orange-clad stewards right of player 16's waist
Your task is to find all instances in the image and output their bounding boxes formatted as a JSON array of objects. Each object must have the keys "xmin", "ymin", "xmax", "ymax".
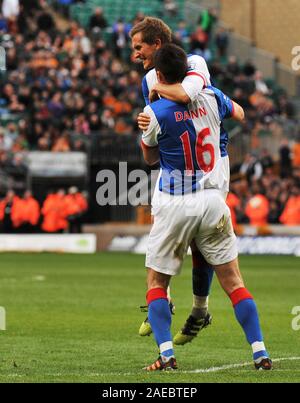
[{"xmin": 227, "ymin": 140, "xmax": 300, "ymax": 228}]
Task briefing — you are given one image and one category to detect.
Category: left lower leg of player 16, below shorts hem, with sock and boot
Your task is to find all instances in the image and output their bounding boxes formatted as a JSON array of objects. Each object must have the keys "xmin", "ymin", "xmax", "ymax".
[{"xmin": 144, "ymin": 268, "xmax": 177, "ymax": 371}]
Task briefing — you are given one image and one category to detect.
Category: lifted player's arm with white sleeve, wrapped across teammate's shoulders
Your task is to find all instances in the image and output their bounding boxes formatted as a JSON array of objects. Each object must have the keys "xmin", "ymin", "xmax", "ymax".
[{"xmin": 149, "ymin": 55, "xmax": 210, "ymax": 104}]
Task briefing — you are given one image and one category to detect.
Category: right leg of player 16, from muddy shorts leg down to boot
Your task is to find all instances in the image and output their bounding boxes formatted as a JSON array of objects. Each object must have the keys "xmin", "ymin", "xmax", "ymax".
[{"xmin": 196, "ymin": 190, "xmax": 272, "ymax": 369}]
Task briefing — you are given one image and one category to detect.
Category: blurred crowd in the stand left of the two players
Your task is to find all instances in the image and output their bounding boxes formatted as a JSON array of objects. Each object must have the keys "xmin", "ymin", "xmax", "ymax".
[{"xmin": 0, "ymin": 0, "xmax": 143, "ymax": 159}]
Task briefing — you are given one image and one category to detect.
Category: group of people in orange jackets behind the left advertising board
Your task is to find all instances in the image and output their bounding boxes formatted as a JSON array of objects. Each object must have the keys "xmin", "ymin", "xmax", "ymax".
[{"xmin": 0, "ymin": 186, "xmax": 88, "ymax": 233}]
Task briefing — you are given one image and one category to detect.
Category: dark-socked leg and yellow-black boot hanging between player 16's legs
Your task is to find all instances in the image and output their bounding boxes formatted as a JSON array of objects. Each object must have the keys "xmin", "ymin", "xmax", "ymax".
[{"xmin": 173, "ymin": 241, "xmax": 214, "ymax": 345}]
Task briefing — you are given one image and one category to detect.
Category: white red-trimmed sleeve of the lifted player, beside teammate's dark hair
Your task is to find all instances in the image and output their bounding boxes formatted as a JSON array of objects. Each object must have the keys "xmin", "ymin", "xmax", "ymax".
[{"xmin": 181, "ymin": 55, "xmax": 210, "ymax": 102}]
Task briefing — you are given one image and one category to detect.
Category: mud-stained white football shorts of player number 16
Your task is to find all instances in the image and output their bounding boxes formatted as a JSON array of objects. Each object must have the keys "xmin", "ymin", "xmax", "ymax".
[{"xmin": 146, "ymin": 189, "xmax": 238, "ymax": 276}]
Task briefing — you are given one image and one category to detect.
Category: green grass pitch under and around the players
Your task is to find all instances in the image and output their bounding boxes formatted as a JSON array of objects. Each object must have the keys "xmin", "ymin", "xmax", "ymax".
[{"xmin": 0, "ymin": 253, "xmax": 300, "ymax": 383}]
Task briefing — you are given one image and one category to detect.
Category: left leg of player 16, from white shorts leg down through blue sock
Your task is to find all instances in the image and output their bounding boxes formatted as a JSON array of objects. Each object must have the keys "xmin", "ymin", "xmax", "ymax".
[{"xmin": 142, "ymin": 193, "xmax": 199, "ymax": 370}]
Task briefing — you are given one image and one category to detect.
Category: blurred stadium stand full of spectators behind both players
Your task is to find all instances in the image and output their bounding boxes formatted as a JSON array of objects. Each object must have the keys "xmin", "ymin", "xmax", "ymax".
[{"xmin": 0, "ymin": 0, "xmax": 300, "ymax": 234}]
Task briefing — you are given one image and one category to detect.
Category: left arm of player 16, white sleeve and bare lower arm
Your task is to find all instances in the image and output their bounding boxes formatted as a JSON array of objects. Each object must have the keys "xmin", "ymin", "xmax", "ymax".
[{"xmin": 141, "ymin": 106, "xmax": 160, "ymax": 166}]
